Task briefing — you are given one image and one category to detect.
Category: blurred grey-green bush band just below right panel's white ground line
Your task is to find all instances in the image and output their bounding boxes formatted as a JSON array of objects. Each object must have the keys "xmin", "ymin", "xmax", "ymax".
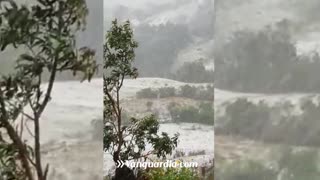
[{"xmin": 216, "ymin": 98, "xmax": 320, "ymax": 146}]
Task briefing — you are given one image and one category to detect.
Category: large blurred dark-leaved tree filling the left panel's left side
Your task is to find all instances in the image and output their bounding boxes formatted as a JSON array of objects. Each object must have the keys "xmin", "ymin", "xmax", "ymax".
[{"xmin": 0, "ymin": 0, "xmax": 96, "ymax": 180}]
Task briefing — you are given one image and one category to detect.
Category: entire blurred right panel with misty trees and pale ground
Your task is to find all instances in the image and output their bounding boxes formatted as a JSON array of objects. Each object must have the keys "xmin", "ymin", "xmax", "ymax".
[{"xmin": 214, "ymin": 0, "xmax": 320, "ymax": 180}]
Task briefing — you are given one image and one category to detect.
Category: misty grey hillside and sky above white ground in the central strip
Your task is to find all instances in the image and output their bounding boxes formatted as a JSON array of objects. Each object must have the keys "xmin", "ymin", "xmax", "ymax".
[{"xmin": 104, "ymin": 0, "xmax": 214, "ymax": 82}]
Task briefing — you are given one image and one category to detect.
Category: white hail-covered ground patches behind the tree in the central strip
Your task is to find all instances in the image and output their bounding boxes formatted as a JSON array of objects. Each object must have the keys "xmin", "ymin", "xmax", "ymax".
[{"xmin": 104, "ymin": 78, "xmax": 214, "ymax": 173}]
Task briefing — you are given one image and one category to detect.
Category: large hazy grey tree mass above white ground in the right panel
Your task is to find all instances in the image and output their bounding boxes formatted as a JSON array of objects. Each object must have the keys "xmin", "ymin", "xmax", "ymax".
[{"xmin": 215, "ymin": 19, "xmax": 320, "ymax": 93}]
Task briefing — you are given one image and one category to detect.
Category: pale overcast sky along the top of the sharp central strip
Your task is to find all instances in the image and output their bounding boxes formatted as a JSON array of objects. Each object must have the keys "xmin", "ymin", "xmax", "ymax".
[{"xmin": 104, "ymin": 0, "xmax": 213, "ymax": 27}]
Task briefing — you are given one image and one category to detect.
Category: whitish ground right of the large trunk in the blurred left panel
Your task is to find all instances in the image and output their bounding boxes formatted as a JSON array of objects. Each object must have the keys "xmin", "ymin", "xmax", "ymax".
[{"xmin": 25, "ymin": 79, "xmax": 103, "ymax": 180}]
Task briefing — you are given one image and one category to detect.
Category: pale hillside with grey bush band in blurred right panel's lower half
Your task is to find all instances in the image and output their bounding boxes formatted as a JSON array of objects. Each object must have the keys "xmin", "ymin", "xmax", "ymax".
[{"xmin": 215, "ymin": 89, "xmax": 320, "ymax": 176}]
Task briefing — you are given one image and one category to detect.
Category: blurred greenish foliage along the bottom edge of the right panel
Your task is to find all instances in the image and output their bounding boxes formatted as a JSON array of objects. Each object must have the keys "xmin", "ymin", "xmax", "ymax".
[{"xmin": 216, "ymin": 146, "xmax": 320, "ymax": 180}]
